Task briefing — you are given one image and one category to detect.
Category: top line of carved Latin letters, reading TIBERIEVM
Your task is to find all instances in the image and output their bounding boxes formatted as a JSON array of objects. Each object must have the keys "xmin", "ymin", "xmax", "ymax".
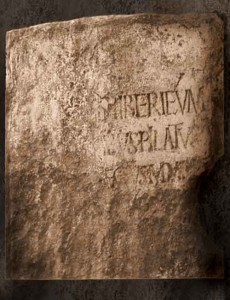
[{"xmin": 98, "ymin": 89, "xmax": 204, "ymax": 121}]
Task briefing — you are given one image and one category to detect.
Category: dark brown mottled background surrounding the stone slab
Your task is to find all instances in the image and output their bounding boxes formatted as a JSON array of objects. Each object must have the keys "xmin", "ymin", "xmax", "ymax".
[{"xmin": 0, "ymin": 0, "xmax": 230, "ymax": 300}]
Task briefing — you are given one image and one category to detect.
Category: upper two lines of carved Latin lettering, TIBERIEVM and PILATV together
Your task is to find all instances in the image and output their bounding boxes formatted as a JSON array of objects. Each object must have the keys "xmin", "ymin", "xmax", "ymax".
[{"xmin": 94, "ymin": 88, "xmax": 207, "ymax": 165}]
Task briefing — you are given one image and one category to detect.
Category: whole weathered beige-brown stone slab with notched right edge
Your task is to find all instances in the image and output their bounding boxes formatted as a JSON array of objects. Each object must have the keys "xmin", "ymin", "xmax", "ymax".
[{"xmin": 6, "ymin": 14, "xmax": 223, "ymax": 279}]
